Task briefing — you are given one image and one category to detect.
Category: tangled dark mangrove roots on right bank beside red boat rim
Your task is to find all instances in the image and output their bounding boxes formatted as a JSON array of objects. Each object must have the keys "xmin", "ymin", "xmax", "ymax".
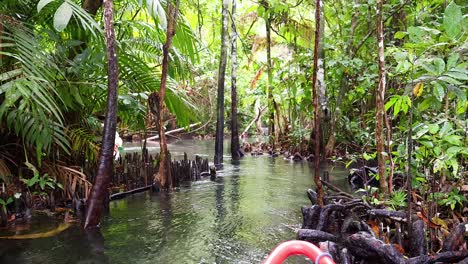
[{"xmin": 297, "ymin": 182, "xmax": 468, "ymax": 264}]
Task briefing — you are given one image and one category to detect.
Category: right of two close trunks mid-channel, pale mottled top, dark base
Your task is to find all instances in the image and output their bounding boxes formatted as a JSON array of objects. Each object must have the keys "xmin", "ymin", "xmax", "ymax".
[{"xmin": 231, "ymin": 0, "xmax": 241, "ymax": 159}]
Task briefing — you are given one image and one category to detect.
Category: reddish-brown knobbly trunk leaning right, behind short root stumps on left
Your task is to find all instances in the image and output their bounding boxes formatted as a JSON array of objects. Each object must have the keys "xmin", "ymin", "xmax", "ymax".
[{"xmin": 152, "ymin": 0, "xmax": 180, "ymax": 189}]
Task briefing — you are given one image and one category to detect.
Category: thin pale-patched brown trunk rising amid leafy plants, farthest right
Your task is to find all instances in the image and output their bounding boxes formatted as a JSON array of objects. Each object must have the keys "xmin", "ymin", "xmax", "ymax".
[{"xmin": 375, "ymin": 0, "xmax": 388, "ymax": 193}]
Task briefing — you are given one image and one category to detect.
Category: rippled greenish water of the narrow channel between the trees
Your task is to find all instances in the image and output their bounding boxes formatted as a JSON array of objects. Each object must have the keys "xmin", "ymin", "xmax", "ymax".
[{"xmin": 0, "ymin": 140, "xmax": 346, "ymax": 263}]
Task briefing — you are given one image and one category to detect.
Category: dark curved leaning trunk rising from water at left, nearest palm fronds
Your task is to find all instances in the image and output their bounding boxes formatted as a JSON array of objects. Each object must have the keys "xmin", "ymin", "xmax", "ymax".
[{"xmin": 84, "ymin": 0, "xmax": 119, "ymax": 228}]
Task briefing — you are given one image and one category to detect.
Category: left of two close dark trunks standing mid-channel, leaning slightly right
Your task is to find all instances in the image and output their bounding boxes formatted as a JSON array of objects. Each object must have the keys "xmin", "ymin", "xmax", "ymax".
[{"xmin": 214, "ymin": 0, "xmax": 229, "ymax": 165}]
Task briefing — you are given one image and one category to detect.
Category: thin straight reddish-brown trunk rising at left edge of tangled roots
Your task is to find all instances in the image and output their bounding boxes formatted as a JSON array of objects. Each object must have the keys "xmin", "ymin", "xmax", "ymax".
[{"xmin": 312, "ymin": 0, "xmax": 323, "ymax": 206}]
